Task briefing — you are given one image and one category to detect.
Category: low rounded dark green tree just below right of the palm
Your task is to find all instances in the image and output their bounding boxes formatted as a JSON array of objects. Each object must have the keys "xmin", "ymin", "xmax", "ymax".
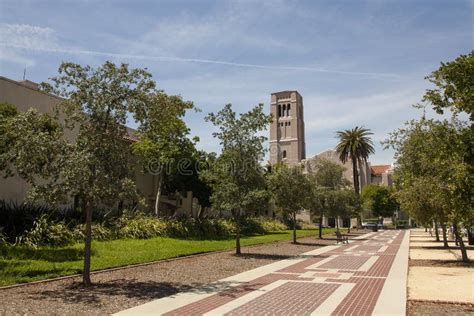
[{"xmin": 361, "ymin": 184, "xmax": 398, "ymax": 223}]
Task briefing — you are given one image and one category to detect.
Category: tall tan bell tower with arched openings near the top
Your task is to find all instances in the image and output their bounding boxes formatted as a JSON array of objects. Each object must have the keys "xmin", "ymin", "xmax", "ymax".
[{"xmin": 269, "ymin": 91, "xmax": 306, "ymax": 165}]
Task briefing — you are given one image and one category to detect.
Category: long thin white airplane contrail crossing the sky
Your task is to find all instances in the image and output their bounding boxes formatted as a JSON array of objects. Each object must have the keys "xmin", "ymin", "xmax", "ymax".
[{"xmin": 0, "ymin": 42, "xmax": 402, "ymax": 79}]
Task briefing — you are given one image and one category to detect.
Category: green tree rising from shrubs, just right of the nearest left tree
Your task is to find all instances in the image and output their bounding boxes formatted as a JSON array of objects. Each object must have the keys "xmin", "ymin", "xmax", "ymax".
[{"xmin": 132, "ymin": 91, "xmax": 197, "ymax": 216}]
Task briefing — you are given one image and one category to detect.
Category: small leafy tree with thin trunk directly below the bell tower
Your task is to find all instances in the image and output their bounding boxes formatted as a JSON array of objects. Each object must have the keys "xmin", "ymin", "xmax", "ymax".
[{"xmin": 268, "ymin": 163, "xmax": 311, "ymax": 244}]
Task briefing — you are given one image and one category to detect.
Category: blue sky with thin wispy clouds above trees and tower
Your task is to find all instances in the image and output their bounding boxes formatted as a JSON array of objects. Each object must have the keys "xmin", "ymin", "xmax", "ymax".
[{"xmin": 0, "ymin": 0, "xmax": 474, "ymax": 164}]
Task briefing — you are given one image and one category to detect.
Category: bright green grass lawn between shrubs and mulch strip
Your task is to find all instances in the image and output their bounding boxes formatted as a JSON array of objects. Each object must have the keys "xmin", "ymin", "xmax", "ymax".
[{"xmin": 0, "ymin": 229, "xmax": 333, "ymax": 286}]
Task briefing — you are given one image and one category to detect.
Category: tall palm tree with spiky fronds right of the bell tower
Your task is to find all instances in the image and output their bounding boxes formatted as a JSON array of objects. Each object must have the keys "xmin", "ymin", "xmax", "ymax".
[{"xmin": 336, "ymin": 126, "xmax": 375, "ymax": 195}]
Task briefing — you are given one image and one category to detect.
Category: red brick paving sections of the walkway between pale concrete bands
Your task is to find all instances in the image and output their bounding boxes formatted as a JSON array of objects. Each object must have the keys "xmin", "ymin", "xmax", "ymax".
[{"xmin": 161, "ymin": 231, "xmax": 405, "ymax": 315}]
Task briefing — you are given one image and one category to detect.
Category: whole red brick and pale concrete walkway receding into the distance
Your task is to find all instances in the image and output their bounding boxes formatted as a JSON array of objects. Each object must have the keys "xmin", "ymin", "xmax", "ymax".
[{"xmin": 118, "ymin": 230, "xmax": 409, "ymax": 315}]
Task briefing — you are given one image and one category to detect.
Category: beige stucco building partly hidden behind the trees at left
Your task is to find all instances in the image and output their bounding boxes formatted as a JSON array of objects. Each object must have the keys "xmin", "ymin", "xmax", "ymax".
[{"xmin": 0, "ymin": 77, "xmax": 197, "ymax": 215}]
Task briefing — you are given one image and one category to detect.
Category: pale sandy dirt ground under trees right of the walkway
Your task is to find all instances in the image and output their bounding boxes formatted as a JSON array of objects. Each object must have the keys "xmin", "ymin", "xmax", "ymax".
[{"xmin": 407, "ymin": 230, "xmax": 474, "ymax": 315}]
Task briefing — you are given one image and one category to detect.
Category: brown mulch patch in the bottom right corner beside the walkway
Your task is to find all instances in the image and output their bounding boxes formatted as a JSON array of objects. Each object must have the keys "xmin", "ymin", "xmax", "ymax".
[{"xmin": 407, "ymin": 300, "xmax": 474, "ymax": 316}]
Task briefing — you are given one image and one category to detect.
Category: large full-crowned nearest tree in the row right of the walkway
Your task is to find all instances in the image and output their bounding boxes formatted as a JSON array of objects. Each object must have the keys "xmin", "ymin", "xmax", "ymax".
[{"xmin": 385, "ymin": 118, "xmax": 474, "ymax": 261}]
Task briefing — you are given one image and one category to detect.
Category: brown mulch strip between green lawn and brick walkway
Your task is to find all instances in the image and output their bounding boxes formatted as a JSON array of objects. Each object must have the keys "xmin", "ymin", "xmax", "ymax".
[{"xmin": 0, "ymin": 230, "xmax": 366, "ymax": 315}]
